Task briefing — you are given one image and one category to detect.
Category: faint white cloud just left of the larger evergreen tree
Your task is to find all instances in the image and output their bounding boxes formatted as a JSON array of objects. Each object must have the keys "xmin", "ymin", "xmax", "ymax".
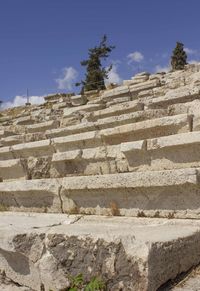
[{"xmin": 55, "ymin": 67, "xmax": 78, "ymax": 90}]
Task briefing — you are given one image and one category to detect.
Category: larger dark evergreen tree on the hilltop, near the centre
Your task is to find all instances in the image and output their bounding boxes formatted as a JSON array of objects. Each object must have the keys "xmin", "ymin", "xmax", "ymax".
[{"xmin": 76, "ymin": 35, "xmax": 115, "ymax": 92}]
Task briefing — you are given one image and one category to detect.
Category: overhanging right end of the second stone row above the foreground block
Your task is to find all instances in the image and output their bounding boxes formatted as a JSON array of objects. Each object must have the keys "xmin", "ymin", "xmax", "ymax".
[{"xmin": 121, "ymin": 132, "xmax": 200, "ymax": 171}]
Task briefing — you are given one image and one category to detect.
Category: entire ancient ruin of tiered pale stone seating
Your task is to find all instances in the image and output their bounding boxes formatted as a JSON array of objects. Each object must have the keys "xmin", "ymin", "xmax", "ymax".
[{"xmin": 0, "ymin": 64, "xmax": 200, "ymax": 291}]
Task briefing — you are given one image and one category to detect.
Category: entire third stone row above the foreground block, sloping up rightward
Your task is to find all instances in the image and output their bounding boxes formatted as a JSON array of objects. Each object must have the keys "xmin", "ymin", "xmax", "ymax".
[{"xmin": 0, "ymin": 114, "xmax": 192, "ymax": 160}]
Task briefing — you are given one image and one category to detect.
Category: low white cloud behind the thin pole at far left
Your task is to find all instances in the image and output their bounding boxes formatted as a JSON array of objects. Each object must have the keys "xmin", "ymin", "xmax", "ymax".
[{"xmin": 1, "ymin": 96, "xmax": 44, "ymax": 109}]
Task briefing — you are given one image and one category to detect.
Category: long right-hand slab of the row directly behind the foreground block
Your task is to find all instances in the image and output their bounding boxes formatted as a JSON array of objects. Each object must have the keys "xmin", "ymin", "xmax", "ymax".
[{"xmin": 61, "ymin": 169, "xmax": 200, "ymax": 218}]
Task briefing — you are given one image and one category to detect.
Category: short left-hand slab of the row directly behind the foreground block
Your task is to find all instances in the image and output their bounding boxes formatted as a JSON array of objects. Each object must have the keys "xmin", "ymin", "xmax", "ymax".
[{"xmin": 0, "ymin": 179, "xmax": 62, "ymax": 213}]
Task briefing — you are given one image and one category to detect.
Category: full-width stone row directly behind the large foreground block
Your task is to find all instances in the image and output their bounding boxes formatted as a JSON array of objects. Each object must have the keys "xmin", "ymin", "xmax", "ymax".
[{"xmin": 0, "ymin": 168, "xmax": 200, "ymax": 218}]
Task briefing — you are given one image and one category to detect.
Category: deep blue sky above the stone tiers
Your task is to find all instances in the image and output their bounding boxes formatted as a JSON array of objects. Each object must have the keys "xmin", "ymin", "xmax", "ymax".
[{"xmin": 0, "ymin": 0, "xmax": 200, "ymax": 107}]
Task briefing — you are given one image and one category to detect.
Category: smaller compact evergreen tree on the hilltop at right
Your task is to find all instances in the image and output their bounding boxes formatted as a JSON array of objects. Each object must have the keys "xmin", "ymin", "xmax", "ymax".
[{"xmin": 171, "ymin": 42, "xmax": 187, "ymax": 71}]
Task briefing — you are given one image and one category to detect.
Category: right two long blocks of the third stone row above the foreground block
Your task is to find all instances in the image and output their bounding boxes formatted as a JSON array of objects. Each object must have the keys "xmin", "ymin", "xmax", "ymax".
[{"xmin": 52, "ymin": 114, "xmax": 192, "ymax": 152}]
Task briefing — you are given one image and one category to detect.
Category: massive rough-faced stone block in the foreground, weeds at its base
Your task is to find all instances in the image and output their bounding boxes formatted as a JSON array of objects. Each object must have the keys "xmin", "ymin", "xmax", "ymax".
[{"xmin": 0, "ymin": 213, "xmax": 200, "ymax": 291}]
